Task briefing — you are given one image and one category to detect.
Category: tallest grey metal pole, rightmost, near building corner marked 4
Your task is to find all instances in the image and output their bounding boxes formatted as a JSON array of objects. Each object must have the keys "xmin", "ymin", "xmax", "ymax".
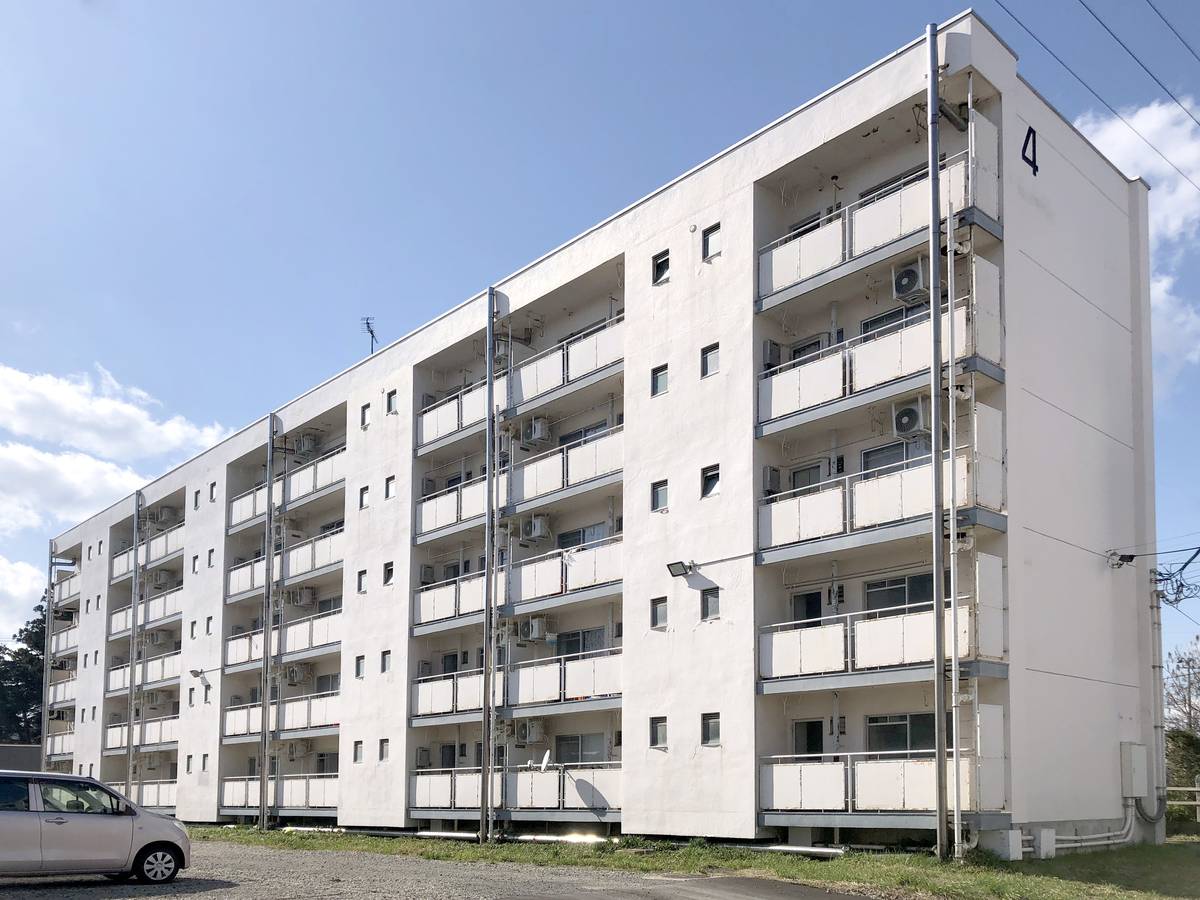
[{"xmin": 925, "ymin": 24, "xmax": 956, "ymax": 859}]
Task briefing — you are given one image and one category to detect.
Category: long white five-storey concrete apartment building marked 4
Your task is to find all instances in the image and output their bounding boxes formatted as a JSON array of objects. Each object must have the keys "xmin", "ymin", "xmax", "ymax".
[{"xmin": 46, "ymin": 13, "xmax": 1163, "ymax": 857}]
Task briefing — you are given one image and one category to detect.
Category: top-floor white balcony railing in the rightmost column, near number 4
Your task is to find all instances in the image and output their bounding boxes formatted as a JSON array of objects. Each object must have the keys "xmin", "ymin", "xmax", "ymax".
[{"xmin": 758, "ymin": 150, "xmax": 972, "ymax": 298}]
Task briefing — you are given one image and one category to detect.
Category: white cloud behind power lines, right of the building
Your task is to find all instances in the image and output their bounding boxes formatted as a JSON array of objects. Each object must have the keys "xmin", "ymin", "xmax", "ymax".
[{"xmin": 1075, "ymin": 97, "xmax": 1200, "ymax": 397}]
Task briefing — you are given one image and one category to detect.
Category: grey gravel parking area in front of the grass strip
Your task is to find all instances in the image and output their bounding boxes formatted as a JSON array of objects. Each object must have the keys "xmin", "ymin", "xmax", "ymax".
[{"xmin": 0, "ymin": 842, "xmax": 846, "ymax": 900}]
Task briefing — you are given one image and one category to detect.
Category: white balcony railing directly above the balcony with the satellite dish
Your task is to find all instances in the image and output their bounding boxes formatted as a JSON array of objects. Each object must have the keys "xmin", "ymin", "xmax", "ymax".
[{"xmin": 413, "ymin": 647, "xmax": 620, "ymax": 715}]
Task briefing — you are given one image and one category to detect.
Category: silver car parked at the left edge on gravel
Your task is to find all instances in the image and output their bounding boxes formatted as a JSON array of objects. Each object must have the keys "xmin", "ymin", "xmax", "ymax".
[{"xmin": 0, "ymin": 769, "xmax": 192, "ymax": 884}]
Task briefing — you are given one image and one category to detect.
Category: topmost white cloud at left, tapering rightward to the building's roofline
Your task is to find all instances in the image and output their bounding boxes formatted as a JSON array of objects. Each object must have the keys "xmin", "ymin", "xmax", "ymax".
[{"xmin": 0, "ymin": 365, "xmax": 227, "ymax": 460}]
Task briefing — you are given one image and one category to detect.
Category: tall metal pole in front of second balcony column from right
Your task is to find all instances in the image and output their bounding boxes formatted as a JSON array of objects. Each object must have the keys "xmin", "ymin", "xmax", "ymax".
[{"xmin": 479, "ymin": 287, "xmax": 496, "ymax": 844}]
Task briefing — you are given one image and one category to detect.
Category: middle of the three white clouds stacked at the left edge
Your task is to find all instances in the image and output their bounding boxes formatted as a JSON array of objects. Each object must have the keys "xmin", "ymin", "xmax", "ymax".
[{"xmin": 0, "ymin": 443, "xmax": 149, "ymax": 535}]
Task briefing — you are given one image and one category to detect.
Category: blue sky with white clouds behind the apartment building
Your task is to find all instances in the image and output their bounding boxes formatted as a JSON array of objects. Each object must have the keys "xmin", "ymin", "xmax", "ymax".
[{"xmin": 0, "ymin": 0, "xmax": 1200, "ymax": 644}]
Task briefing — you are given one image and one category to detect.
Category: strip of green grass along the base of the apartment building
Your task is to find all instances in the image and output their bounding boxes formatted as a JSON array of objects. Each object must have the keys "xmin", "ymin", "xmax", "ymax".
[{"xmin": 188, "ymin": 827, "xmax": 1200, "ymax": 900}]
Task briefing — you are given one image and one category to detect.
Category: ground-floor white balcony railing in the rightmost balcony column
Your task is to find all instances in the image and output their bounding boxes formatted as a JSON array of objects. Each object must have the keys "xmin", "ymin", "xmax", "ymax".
[{"xmin": 758, "ymin": 750, "xmax": 1003, "ymax": 812}]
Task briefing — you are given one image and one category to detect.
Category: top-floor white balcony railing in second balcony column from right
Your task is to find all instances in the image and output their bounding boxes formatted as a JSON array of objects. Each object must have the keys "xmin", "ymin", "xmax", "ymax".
[{"xmin": 416, "ymin": 316, "xmax": 624, "ymax": 446}]
